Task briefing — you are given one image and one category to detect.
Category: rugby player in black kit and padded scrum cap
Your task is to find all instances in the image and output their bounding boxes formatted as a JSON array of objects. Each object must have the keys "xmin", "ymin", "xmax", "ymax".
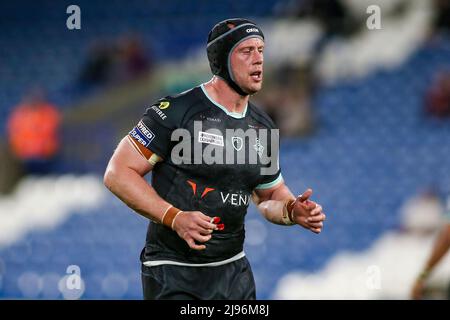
[{"xmin": 104, "ymin": 19, "xmax": 325, "ymax": 299}]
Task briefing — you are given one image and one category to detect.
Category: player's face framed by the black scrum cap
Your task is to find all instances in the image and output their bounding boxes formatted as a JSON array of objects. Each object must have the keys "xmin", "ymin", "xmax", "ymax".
[{"xmin": 231, "ymin": 38, "xmax": 264, "ymax": 94}]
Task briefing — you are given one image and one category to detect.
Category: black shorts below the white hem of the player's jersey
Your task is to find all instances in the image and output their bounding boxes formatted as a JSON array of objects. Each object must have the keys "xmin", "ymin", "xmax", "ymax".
[{"xmin": 141, "ymin": 257, "xmax": 256, "ymax": 300}]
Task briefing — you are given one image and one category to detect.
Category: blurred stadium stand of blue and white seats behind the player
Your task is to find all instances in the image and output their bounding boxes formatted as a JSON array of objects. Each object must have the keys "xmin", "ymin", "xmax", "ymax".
[{"xmin": 0, "ymin": 0, "xmax": 450, "ymax": 299}]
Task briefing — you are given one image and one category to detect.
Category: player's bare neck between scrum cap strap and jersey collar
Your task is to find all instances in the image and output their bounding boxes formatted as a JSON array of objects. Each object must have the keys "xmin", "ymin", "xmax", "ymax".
[{"xmin": 204, "ymin": 77, "xmax": 249, "ymax": 113}]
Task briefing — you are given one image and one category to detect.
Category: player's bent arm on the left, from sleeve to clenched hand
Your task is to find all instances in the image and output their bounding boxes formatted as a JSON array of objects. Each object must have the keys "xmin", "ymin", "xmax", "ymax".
[{"xmin": 104, "ymin": 136, "xmax": 217, "ymax": 250}]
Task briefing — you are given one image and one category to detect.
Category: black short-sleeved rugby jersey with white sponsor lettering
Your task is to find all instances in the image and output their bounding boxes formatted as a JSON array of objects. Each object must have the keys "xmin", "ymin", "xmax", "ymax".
[{"xmin": 130, "ymin": 85, "xmax": 282, "ymax": 264}]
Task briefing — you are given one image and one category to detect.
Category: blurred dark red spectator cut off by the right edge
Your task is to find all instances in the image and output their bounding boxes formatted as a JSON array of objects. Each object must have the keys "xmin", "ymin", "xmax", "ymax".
[{"xmin": 425, "ymin": 71, "xmax": 450, "ymax": 118}]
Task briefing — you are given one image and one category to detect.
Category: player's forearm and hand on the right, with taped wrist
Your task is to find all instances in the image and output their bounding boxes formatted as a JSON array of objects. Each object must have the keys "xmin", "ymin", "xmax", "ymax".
[{"xmin": 253, "ymin": 181, "xmax": 326, "ymax": 233}]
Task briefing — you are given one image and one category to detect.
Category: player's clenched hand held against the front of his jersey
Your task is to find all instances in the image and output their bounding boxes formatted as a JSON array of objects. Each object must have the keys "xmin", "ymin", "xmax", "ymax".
[{"xmin": 173, "ymin": 211, "xmax": 223, "ymax": 250}]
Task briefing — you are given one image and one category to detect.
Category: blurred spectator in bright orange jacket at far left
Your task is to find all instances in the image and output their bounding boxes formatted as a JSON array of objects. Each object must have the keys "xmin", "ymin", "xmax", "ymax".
[{"xmin": 7, "ymin": 90, "xmax": 61, "ymax": 174}]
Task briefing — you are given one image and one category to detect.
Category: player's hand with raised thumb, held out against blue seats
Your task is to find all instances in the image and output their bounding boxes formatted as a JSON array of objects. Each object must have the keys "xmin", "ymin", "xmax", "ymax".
[{"xmin": 292, "ymin": 189, "xmax": 326, "ymax": 233}]
